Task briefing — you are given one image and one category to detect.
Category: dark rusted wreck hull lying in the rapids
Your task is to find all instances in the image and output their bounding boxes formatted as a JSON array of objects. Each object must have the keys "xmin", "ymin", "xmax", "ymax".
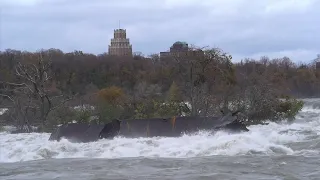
[{"xmin": 49, "ymin": 113, "xmax": 249, "ymax": 142}]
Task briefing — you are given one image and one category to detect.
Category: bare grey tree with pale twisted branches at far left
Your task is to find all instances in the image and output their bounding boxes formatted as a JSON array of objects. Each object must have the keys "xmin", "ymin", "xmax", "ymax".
[{"xmin": 1, "ymin": 52, "xmax": 71, "ymax": 131}]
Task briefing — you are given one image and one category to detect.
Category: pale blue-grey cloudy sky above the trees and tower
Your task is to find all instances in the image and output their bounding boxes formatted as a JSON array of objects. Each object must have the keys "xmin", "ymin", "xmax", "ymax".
[{"xmin": 0, "ymin": 0, "xmax": 320, "ymax": 61}]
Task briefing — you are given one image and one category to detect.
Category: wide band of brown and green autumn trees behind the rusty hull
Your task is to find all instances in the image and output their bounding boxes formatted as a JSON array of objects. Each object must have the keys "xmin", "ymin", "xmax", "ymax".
[{"xmin": 0, "ymin": 49, "xmax": 320, "ymax": 131}]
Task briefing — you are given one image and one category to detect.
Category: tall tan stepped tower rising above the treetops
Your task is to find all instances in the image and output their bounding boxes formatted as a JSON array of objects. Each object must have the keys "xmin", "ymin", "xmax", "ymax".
[{"xmin": 109, "ymin": 29, "xmax": 132, "ymax": 56}]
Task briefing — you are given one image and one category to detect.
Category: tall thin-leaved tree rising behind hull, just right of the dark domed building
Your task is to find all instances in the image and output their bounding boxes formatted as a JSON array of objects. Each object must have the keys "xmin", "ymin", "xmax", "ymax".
[{"xmin": 173, "ymin": 48, "xmax": 232, "ymax": 116}]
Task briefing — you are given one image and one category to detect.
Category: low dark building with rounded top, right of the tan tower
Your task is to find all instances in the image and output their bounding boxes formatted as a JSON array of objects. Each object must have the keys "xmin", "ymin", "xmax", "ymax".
[{"xmin": 160, "ymin": 41, "xmax": 204, "ymax": 58}]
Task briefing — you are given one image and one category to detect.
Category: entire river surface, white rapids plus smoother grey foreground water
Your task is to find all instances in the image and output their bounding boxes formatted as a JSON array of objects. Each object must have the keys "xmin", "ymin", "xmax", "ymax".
[{"xmin": 0, "ymin": 99, "xmax": 320, "ymax": 180}]
